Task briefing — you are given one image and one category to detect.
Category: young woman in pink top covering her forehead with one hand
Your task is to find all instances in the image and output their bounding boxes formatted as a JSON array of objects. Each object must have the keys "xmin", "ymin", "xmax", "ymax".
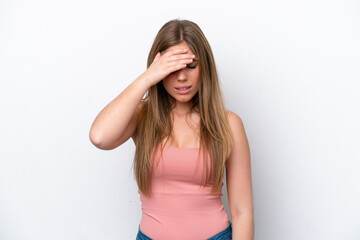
[{"xmin": 89, "ymin": 19, "xmax": 254, "ymax": 240}]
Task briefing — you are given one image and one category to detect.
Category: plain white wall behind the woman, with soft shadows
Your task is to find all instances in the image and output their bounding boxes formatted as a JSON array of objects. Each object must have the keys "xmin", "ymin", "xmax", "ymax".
[{"xmin": 0, "ymin": 0, "xmax": 360, "ymax": 240}]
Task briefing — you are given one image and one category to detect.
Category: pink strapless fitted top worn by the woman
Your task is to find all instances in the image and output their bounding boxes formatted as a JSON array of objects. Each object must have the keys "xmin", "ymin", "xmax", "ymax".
[{"xmin": 138, "ymin": 146, "xmax": 229, "ymax": 240}]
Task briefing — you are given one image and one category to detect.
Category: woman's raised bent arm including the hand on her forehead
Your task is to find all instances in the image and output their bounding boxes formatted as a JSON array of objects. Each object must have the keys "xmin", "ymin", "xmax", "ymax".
[{"xmin": 89, "ymin": 48, "xmax": 195, "ymax": 150}]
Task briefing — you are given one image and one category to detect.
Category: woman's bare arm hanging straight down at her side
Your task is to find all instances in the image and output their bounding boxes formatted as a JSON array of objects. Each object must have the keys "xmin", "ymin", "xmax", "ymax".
[{"xmin": 226, "ymin": 111, "xmax": 254, "ymax": 240}]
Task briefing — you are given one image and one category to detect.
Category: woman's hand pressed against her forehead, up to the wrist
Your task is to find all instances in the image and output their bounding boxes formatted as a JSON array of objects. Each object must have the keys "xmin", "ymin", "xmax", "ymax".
[{"xmin": 143, "ymin": 49, "xmax": 195, "ymax": 86}]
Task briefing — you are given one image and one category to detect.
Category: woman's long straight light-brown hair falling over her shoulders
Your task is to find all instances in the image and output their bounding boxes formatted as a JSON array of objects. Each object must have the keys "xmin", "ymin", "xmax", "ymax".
[{"xmin": 133, "ymin": 19, "xmax": 232, "ymax": 196}]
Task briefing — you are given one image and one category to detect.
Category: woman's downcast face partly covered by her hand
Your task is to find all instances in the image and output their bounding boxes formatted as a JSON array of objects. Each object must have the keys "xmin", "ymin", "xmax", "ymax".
[{"xmin": 162, "ymin": 42, "xmax": 200, "ymax": 106}]
